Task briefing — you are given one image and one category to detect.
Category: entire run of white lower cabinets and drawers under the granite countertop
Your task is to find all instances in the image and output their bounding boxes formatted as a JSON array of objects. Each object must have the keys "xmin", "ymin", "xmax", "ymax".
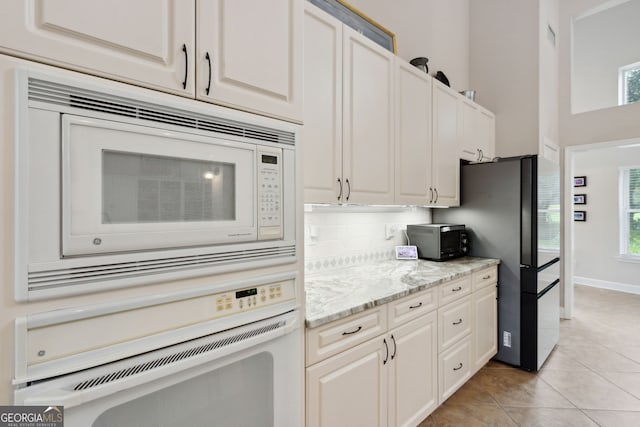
[{"xmin": 306, "ymin": 267, "xmax": 497, "ymax": 427}]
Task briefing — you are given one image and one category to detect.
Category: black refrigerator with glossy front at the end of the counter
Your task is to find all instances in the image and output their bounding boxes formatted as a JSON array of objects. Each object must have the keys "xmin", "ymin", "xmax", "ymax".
[{"xmin": 432, "ymin": 155, "xmax": 560, "ymax": 371}]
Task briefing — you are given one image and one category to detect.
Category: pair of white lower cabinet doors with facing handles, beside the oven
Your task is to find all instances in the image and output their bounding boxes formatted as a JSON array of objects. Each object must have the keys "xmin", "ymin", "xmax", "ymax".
[{"xmin": 307, "ymin": 312, "xmax": 438, "ymax": 427}]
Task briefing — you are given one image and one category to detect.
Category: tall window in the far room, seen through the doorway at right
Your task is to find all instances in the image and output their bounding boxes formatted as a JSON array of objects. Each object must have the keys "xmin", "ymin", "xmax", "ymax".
[{"xmin": 620, "ymin": 167, "xmax": 640, "ymax": 258}]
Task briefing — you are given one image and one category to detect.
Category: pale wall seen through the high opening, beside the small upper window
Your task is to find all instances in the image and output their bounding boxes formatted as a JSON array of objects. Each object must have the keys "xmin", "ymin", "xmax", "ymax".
[{"xmin": 571, "ymin": 0, "xmax": 640, "ymax": 113}]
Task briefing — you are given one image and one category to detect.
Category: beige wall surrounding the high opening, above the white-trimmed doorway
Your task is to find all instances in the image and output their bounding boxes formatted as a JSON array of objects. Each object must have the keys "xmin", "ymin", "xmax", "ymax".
[{"xmin": 559, "ymin": 0, "xmax": 640, "ymax": 146}]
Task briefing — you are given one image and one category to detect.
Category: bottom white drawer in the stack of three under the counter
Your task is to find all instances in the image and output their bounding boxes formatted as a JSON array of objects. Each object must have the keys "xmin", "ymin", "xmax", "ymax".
[{"xmin": 438, "ymin": 337, "xmax": 471, "ymax": 404}]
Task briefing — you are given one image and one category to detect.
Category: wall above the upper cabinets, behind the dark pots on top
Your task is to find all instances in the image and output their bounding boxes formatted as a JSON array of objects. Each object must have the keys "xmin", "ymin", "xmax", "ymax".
[{"xmin": 347, "ymin": 0, "xmax": 470, "ymax": 91}]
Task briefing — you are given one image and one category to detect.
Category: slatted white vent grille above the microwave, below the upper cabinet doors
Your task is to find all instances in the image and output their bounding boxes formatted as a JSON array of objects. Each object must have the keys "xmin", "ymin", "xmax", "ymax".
[{"xmin": 29, "ymin": 77, "xmax": 295, "ymax": 145}]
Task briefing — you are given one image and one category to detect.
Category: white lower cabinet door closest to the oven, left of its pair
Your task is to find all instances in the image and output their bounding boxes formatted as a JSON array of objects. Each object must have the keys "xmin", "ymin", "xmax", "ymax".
[{"xmin": 306, "ymin": 337, "xmax": 390, "ymax": 427}]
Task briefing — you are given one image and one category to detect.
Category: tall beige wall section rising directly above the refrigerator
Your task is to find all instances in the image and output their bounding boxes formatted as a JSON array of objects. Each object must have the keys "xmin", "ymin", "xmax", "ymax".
[{"xmin": 469, "ymin": 0, "xmax": 539, "ymax": 157}]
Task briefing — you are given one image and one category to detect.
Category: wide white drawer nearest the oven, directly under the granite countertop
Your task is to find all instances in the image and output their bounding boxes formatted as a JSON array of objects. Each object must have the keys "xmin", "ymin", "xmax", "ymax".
[{"xmin": 306, "ymin": 306, "xmax": 387, "ymax": 366}]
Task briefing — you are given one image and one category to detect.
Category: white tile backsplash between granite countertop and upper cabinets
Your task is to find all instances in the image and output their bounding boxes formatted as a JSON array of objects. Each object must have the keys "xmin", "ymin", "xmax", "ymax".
[{"xmin": 304, "ymin": 205, "xmax": 431, "ymax": 274}]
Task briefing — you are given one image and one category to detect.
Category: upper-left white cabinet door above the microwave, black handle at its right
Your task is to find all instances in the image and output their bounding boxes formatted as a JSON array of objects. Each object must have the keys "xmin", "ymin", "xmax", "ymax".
[{"xmin": 0, "ymin": 0, "xmax": 195, "ymax": 96}]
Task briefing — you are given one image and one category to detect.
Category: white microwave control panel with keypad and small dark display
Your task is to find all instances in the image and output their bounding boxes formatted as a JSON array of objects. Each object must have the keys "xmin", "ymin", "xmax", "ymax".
[{"xmin": 258, "ymin": 147, "xmax": 282, "ymax": 240}]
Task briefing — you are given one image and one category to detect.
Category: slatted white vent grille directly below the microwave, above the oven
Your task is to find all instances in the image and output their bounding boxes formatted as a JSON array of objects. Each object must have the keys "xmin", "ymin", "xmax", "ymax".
[{"xmin": 28, "ymin": 245, "xmax": 296, "ymax": 291}]
